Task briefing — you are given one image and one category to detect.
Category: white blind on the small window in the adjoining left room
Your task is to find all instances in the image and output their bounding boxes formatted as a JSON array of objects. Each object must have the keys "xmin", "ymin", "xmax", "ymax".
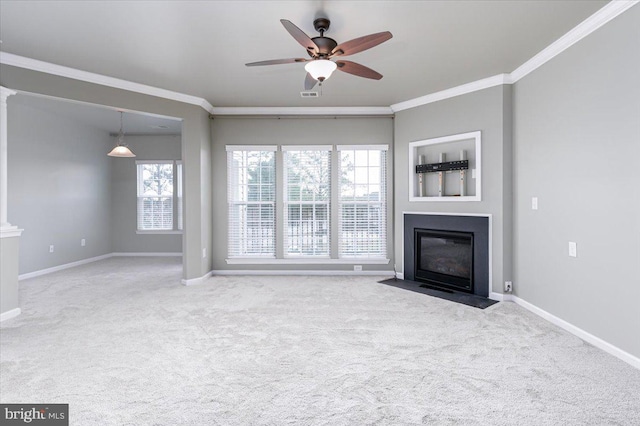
[{"xmin": 136, "ymin": 161, "xmax": 173, "ymax": 231}]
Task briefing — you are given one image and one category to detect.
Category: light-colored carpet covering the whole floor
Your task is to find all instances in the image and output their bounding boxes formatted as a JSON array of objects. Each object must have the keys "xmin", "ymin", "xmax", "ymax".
[{"xmin": 0, "ymin": 258, "xmax": 640, "ymax": 425}]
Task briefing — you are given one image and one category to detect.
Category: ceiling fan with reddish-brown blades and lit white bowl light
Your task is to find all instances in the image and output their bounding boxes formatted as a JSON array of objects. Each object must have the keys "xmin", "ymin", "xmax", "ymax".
[{"xmin": 246, "ymin": 18, "xmax": 393, "ymax": 90}]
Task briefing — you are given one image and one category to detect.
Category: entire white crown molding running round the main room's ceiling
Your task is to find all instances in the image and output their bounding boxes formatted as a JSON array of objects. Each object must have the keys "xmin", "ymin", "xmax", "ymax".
[{"xmin": 0, "ymin": 0, "xmax": 640, "ymax": 116}]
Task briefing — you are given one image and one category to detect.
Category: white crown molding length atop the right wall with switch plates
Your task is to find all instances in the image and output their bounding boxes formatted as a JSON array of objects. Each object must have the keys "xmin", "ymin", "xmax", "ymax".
[{"xmin": 511, "ymin": 0, "xmax": 639, "ymax": 83}]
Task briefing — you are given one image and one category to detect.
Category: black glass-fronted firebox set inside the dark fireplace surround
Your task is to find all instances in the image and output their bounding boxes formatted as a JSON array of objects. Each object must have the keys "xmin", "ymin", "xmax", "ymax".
[{"xmin": 414, "ymin": 228, "xmax": 473, "ymax": 293}]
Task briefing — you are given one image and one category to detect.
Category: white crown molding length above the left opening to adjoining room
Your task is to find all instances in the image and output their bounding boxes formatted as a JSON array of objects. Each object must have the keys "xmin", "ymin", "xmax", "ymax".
[{"xmin": 0, "ymin": 52, "xmax": 213, "ymax": 113}]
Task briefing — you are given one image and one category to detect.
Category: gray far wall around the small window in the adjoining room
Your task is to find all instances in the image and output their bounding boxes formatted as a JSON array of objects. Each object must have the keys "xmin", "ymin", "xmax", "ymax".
[{"xmin": 110, "ymin": 135, "xmax": 182, "ymax": 253}]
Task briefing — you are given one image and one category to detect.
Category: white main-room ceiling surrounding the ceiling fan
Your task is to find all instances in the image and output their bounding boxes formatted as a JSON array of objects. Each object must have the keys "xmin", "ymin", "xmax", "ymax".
[{"xmin": 0, "ymin": 0, "xmax": 607, "ymax": 107}]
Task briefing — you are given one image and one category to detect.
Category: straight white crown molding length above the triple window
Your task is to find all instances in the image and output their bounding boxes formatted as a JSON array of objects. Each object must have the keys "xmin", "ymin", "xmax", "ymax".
[{"xmin": 212, "ymin": 107, "xmax": 393, "ymax": 116}]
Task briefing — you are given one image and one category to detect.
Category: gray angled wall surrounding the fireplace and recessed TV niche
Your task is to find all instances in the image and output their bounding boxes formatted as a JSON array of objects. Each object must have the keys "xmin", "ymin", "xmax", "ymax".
[{"xmin": 394, "ymin": 86, "xmax": 512, "ymax": 293}]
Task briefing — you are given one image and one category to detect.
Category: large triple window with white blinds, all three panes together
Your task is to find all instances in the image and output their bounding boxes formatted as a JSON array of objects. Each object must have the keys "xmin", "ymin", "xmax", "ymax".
[{"xmin": 226, "ymin": 145, "xmax": 388, "ymax": 264}]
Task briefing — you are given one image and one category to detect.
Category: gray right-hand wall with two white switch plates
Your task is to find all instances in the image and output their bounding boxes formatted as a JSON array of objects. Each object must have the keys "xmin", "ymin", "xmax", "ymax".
[{"xmin": 514, "ymin": 6, "xmax": 640, "ymax": 357}]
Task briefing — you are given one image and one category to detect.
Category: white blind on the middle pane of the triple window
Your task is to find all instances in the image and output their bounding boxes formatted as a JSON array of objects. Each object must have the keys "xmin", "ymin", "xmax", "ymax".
[{"xmin": 283, "ymin": 146, "xmax": 331, "ymax": 258}]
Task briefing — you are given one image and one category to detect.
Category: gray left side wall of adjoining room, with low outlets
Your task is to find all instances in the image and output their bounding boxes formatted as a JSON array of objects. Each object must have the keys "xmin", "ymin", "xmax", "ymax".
[{"xmin": 7, "ymin": 95, "xmax": 113, "ymax": 274}]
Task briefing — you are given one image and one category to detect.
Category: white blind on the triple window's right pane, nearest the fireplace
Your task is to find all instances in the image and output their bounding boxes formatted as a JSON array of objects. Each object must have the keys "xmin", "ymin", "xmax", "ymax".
[{"xmin": 338, "ymin": 145, "xmax": 388, "ymax": 258}]
